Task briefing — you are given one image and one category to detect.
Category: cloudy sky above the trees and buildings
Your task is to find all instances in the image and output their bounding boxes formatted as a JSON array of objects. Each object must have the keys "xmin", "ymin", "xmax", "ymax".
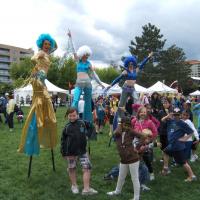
[{"xmin": 0, "ymin": 0, "xmax": 200, "ymax": 63}]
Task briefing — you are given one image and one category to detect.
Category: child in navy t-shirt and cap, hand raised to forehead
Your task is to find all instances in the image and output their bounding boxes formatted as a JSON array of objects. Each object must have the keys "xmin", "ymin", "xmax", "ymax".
[{"xmin": 164, "ymin": 108, "xmax": 196, "ymax": 182}]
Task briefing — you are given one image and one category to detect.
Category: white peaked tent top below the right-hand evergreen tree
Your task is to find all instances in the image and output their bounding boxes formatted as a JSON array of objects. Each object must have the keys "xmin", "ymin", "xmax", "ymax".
[{"xmin": 147, "ymin": 81, "xmax": 177, "ymax": 93}]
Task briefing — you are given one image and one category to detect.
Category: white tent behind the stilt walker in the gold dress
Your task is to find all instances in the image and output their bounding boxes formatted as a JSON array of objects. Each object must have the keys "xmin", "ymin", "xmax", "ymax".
[{"xmin": 14, "ymin": 79, "xmax": 69, "ymax": 105}]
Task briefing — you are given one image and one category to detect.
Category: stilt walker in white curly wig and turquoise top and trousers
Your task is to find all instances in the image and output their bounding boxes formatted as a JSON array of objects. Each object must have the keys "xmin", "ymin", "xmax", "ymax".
[{"xmin": 68, "ymin": 31, "xmax": 104, "ymax": 122}]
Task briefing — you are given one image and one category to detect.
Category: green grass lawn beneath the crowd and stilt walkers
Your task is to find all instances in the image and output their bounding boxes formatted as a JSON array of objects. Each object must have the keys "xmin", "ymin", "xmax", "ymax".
[{"xmin": 0, "ymin": 108, "xmax": 200, "ymax": 200}]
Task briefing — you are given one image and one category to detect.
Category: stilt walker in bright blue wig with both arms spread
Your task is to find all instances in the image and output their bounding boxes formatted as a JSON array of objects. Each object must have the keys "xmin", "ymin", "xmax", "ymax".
[{"xmin": 105, "ymin": 52, "xmax": 153, "ymax": 130}]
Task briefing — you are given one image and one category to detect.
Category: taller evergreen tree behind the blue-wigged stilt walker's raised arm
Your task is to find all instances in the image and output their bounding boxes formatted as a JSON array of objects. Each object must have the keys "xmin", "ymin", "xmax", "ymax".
[{"xmin": 129, "ymin": 23, "xmax": 166, "ymax": 87}]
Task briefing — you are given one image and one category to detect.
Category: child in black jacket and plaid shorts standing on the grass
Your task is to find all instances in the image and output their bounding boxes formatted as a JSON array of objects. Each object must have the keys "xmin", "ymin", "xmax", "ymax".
[{"xmin": 61, "ymin": 108, "xmax": 98, "ymax": 195}]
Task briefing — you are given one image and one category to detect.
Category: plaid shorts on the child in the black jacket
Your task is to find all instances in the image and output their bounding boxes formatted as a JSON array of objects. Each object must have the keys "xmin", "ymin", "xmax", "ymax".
[{"xmin": 65, "ymin": 153, "xmax": 92, "ymax": 169}]
